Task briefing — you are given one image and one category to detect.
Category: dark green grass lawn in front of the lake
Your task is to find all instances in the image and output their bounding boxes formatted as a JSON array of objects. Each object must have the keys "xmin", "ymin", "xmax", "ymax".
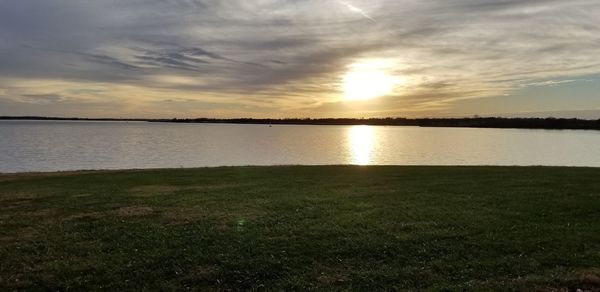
[{"xmin": 0, "ymin": 166, "xmax": 600, "ymax": 291}]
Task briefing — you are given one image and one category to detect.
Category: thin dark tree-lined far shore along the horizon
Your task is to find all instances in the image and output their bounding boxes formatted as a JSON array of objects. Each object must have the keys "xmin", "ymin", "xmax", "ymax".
[{"xmin": 0, "ymin": 116, "xmax": 600, "ymax": 130}]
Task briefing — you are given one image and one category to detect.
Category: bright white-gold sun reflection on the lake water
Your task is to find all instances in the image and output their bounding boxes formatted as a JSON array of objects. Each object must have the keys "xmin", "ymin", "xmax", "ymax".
[{"xmin": 348, "ymin": 126, "xmax": 375, "ymax": 165}]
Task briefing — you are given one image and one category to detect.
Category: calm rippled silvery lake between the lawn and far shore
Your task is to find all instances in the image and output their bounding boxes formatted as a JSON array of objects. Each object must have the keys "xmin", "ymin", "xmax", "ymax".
[{"xmin": 0, "ymin": 121, "xmax": 600, "ymax": 172}]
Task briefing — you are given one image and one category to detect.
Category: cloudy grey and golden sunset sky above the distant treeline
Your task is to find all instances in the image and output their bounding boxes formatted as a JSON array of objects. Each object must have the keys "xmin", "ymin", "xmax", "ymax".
[{"xmin": 0, "ymin": 0, "xmax": 600, "ymax": 119}]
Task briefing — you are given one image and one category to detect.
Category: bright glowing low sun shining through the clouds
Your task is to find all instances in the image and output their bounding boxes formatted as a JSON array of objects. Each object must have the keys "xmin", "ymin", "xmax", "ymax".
[{"xmin": 343, "ymin": 60, "xmax": 401, "ymax": 100}]
